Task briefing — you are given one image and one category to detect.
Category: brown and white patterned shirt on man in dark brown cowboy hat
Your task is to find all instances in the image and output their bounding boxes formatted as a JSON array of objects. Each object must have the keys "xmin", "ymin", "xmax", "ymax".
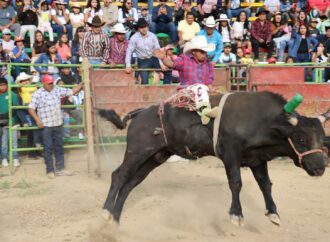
[{"xmin": 80, "ymin": 31, "xmax": 110, "ymax": 63}]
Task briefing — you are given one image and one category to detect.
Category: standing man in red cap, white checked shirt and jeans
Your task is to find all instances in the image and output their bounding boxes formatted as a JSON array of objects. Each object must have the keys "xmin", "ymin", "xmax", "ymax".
[{"xmin": 29, "ymin": 74, "xmax": 82, "ymax": 179}]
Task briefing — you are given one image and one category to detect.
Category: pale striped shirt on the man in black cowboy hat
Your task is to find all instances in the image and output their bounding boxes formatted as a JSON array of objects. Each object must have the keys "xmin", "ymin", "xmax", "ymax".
[{"xmin": 126, "ymin": 31, "xmax": 160, "ymax": 67}]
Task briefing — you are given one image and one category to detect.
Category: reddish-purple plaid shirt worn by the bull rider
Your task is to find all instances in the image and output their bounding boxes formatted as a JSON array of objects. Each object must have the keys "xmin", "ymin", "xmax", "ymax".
[{"xmin": 173, "ymin": 54, "xmax": 214, "ymax": 85}]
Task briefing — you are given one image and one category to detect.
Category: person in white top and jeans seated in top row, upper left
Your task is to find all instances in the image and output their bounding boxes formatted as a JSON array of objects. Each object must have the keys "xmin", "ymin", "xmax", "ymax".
[{"xmin": 50, "ymin": 0, "xmax": 72, "ymax": 40}]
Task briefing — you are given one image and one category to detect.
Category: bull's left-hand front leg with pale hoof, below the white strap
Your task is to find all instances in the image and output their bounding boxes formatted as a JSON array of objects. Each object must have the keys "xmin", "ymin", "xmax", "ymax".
[{"xmin": 224, "ymin": 162, "xmax": 244, "ymax": 226}]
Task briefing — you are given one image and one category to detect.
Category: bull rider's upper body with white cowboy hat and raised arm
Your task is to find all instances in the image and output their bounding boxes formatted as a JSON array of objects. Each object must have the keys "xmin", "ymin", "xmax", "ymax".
[{"xmin": 155, "ymin": 35, "xmax": 215, "ymax": 86}]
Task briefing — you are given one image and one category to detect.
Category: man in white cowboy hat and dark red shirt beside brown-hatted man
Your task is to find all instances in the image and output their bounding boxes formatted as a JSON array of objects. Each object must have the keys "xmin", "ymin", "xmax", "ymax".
[{"xmin": 108, "ymin": 23, "xmax": 128, "ymax": 67}]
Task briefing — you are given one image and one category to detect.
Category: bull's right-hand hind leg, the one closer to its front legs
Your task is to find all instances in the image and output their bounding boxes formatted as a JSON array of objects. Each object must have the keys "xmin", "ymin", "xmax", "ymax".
[{"xmin": 112, "ymin": 151, "xmax": 171, "ymax": 222}]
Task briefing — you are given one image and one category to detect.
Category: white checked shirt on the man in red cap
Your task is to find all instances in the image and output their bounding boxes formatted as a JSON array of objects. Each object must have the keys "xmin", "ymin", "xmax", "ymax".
[{"xmin": 29, "ymin": 86, "xmax": 72, "ymax": 127}]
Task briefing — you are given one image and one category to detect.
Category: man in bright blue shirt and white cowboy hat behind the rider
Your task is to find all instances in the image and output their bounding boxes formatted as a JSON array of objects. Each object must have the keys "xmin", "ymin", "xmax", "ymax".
[{"xmin": 197, "ymin": 16, "xmax": 223, "ymax": 66}]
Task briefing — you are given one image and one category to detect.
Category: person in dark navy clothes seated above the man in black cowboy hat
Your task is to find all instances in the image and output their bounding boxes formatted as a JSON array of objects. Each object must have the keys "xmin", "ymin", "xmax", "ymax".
[{"xmin": 150, "ymin": 0, "xmax": 177, "ymax": 45}]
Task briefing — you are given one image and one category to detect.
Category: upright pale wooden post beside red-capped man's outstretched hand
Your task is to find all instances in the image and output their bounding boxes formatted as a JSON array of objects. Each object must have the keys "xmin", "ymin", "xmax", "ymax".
[{"xmin": 82, "ymin": 58, "xmax": 96, "ymax": 174}]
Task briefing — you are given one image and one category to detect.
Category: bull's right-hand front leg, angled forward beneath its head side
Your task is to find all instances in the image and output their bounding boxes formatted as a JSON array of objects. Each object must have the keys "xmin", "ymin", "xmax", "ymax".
[{"xmin": 251, "ymin": 162, "xmax": 281, "ymax": 225}]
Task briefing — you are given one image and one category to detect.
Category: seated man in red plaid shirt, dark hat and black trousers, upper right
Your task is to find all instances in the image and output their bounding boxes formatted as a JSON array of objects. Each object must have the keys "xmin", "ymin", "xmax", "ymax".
[{"xmin": 251, "ymin": 8, "xmax": 274, "ymax": 61}]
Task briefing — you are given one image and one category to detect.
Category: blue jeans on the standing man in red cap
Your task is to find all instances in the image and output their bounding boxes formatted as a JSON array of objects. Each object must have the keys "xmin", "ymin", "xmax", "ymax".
[{"xmin": 42, "ymin": 126, "xmax": 64, "ymax": 173}]
